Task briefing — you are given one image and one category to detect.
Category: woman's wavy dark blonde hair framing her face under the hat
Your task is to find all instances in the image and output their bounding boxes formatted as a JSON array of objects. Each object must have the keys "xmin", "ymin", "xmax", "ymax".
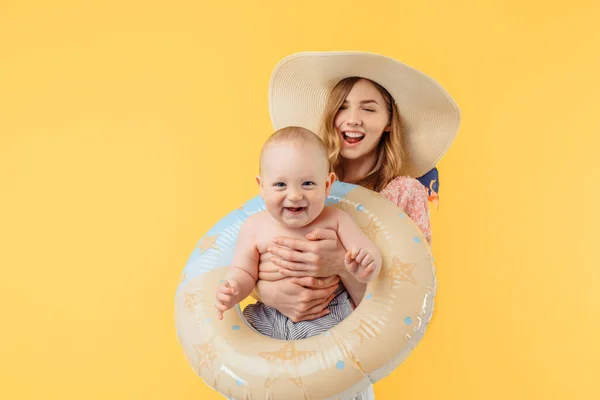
[{"xmin": 319, "ymin": 76, "xmax": 404, "ymax": 192}]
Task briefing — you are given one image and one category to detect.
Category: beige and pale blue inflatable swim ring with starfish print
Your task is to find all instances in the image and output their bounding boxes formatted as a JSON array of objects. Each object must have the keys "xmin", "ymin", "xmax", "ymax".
[{"xmin": 175, "ymin": 182, "xmax": 436, "ymax": 400}]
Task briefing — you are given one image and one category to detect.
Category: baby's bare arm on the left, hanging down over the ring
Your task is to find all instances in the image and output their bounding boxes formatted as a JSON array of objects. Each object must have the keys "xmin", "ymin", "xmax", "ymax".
[{"xmin": 215, "ymin": 217, "xmax": 259, "ymax": 319}]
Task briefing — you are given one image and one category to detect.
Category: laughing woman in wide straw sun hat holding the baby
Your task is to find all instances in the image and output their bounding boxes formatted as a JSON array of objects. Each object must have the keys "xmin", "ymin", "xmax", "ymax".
[{"xmin": 257, "ymin": 52, "xmax": 460, "ymax": 398}]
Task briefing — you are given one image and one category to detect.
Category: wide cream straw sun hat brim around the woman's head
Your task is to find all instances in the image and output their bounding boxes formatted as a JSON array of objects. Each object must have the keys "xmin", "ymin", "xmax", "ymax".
[{"xmin": 269, "ymin": 52, "xmax": 460, "ymax": 177}]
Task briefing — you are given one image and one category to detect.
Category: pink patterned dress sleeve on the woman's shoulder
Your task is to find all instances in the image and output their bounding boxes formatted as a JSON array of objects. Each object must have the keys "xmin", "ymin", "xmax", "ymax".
[{"xmin": 381, "ymin": 176, "xmax": 431, "ymax": 244}]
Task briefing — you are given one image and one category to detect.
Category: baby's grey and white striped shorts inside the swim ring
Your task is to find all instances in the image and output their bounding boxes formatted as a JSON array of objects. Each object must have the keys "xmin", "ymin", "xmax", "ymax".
[{"xmin": 244, "ymin": 284, "xmax": 353, "ymax": 340}]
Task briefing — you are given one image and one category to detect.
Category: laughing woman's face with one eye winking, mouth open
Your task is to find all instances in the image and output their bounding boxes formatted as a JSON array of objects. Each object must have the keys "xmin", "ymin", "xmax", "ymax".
[{"xmin": 334, "ymin": 79, "xmax": 389, "ymax": 161}]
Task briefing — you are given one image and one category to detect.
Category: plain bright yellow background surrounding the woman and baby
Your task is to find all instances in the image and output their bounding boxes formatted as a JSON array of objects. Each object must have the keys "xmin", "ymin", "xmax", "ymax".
[{"xmin": 0, "ymin": 0, "xmax": 600, "ymax": 400}]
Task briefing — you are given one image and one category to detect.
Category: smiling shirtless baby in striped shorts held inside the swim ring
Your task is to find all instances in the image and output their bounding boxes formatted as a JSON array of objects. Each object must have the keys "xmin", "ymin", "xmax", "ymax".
[{"xmin": 216, "ymin": 127, "xmax": 382, "ymax": 340}]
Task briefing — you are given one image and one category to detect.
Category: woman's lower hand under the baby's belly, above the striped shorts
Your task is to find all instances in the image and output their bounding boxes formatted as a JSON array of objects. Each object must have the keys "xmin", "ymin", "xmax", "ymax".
[{"xmin": 256, "ymin": 276, "xmax": 340, "ymax": 322}]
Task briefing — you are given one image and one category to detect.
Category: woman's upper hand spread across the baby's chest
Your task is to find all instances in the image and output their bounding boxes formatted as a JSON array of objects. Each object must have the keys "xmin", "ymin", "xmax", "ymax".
[{"xmin": 268, "ymin": 228, "xmax": 346, "ymax": 277}]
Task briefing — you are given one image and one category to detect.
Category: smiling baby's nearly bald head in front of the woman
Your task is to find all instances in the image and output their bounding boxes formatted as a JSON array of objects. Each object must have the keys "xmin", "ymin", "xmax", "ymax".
[{"xmin": 256, "ymin": 126, "xmax": 335, "ymax": 228}]
